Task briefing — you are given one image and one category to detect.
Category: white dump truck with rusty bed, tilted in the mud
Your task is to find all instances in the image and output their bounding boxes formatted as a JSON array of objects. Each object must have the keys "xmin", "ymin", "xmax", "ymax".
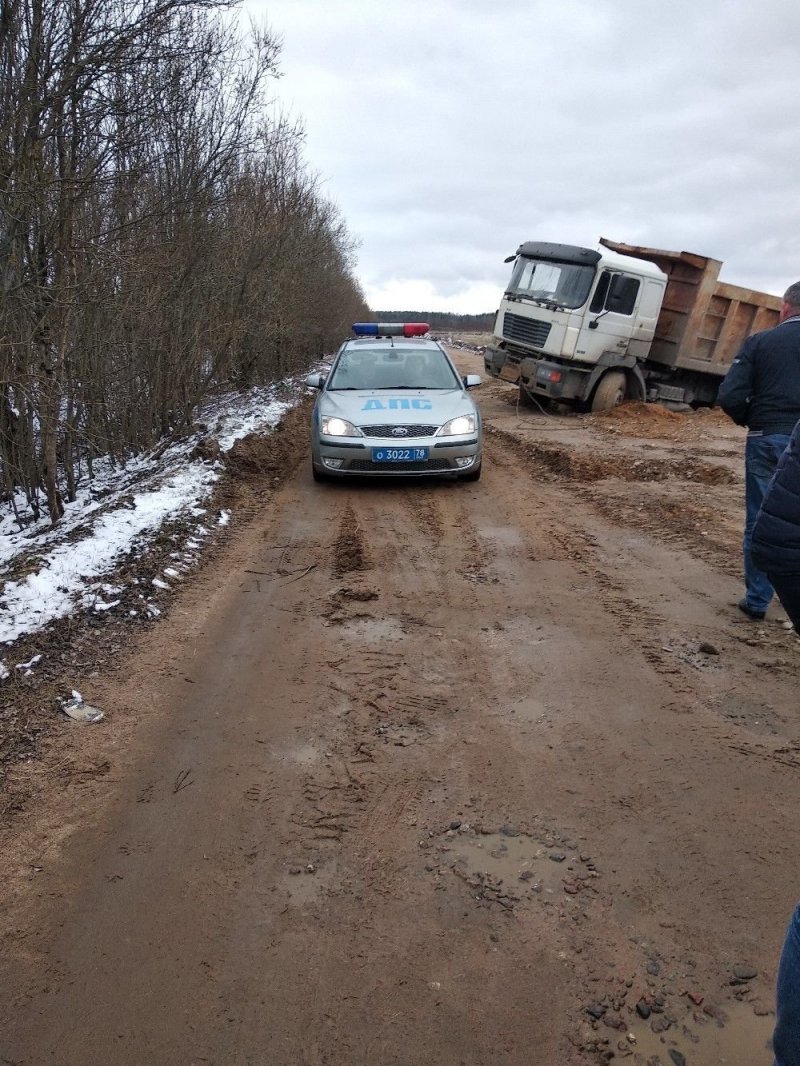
[{"xmin": 483, "ymin": 238, "xmax": 781, "ymax": 411}]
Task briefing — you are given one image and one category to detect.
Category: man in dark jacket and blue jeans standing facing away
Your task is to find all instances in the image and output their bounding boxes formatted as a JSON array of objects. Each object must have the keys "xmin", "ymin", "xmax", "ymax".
[{"xmin": 718, "ymin": 281, "xmax": 800, "ymax": 620}]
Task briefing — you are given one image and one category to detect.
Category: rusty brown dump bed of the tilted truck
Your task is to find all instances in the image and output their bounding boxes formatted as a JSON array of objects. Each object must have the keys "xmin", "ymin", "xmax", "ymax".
[{"xmin": 601, "ymin": 237, "xmax": 781, "ymax": 376}]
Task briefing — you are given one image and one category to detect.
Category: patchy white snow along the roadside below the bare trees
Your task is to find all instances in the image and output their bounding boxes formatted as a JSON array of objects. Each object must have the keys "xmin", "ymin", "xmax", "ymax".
[{"xmin": 0, "ymin": 381, "xmax": 304, "ymax": 648}]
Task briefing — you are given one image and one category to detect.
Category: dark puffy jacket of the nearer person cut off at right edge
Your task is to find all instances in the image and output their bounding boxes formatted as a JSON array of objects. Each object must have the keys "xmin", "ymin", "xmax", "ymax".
[{"xmin": 752, "ymin": 425, "xmax": 800, "ymax": 576}]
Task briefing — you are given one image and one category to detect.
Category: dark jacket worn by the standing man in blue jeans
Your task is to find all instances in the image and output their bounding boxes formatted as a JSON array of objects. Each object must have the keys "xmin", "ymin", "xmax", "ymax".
[{"xmin": 717, "ymin": 318, "xmax": 800, "ymax": 434}]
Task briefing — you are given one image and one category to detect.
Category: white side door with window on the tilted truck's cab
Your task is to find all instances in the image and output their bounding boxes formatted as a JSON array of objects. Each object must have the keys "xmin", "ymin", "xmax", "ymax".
[{"xmin": 575, "ymin": 270, "xmax": 653, "ymax": 362}]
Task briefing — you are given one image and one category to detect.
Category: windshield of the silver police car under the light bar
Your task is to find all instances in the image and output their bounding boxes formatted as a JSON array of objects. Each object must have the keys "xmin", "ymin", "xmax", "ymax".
[{"xmin": 327, "ymin": 345, "xmax": 459, "ymax": 389}]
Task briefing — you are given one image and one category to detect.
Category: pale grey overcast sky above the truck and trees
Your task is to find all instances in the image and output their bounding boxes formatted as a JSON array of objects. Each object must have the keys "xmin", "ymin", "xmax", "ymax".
[{"xmin": 243, "ymin": 0, "xmax": 800, "ymax": 313}]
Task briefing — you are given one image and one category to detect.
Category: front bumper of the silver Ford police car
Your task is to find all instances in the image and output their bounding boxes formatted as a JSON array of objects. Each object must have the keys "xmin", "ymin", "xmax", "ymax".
[{"xmin": 313, "ymin": 436, "xmax": 481, "ymax": 478}]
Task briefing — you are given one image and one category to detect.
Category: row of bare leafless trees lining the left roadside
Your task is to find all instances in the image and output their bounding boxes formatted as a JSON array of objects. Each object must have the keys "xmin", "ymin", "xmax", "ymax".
[{"xmin": 0, "ymin": 0, "xmax": 368, "ymax": 522}]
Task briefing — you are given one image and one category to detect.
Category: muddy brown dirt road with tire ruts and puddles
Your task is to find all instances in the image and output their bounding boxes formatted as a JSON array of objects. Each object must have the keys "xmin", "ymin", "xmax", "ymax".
[{"xmin": 0, "ymin": 355, "xmax": 800, "ymax": 1066}]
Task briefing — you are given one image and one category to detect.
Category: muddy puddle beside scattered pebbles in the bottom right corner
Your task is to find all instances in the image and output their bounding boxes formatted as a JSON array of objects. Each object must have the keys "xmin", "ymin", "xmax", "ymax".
[{"xmin": 625, "ymin": 1003, "xmax": 774, "ymax": 1066}]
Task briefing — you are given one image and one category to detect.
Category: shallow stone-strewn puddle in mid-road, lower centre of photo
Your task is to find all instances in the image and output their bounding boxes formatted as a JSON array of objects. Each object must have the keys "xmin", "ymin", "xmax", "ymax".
[{"xmin": 437, "ymin": 828, "xmax": 599, "ymax": 906}]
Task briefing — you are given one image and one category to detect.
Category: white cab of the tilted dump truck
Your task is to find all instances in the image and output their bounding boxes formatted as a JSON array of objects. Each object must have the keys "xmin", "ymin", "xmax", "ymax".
[{"xmin": 484, "ymin": 241, "xmax": 667, "ymax": 410}]
